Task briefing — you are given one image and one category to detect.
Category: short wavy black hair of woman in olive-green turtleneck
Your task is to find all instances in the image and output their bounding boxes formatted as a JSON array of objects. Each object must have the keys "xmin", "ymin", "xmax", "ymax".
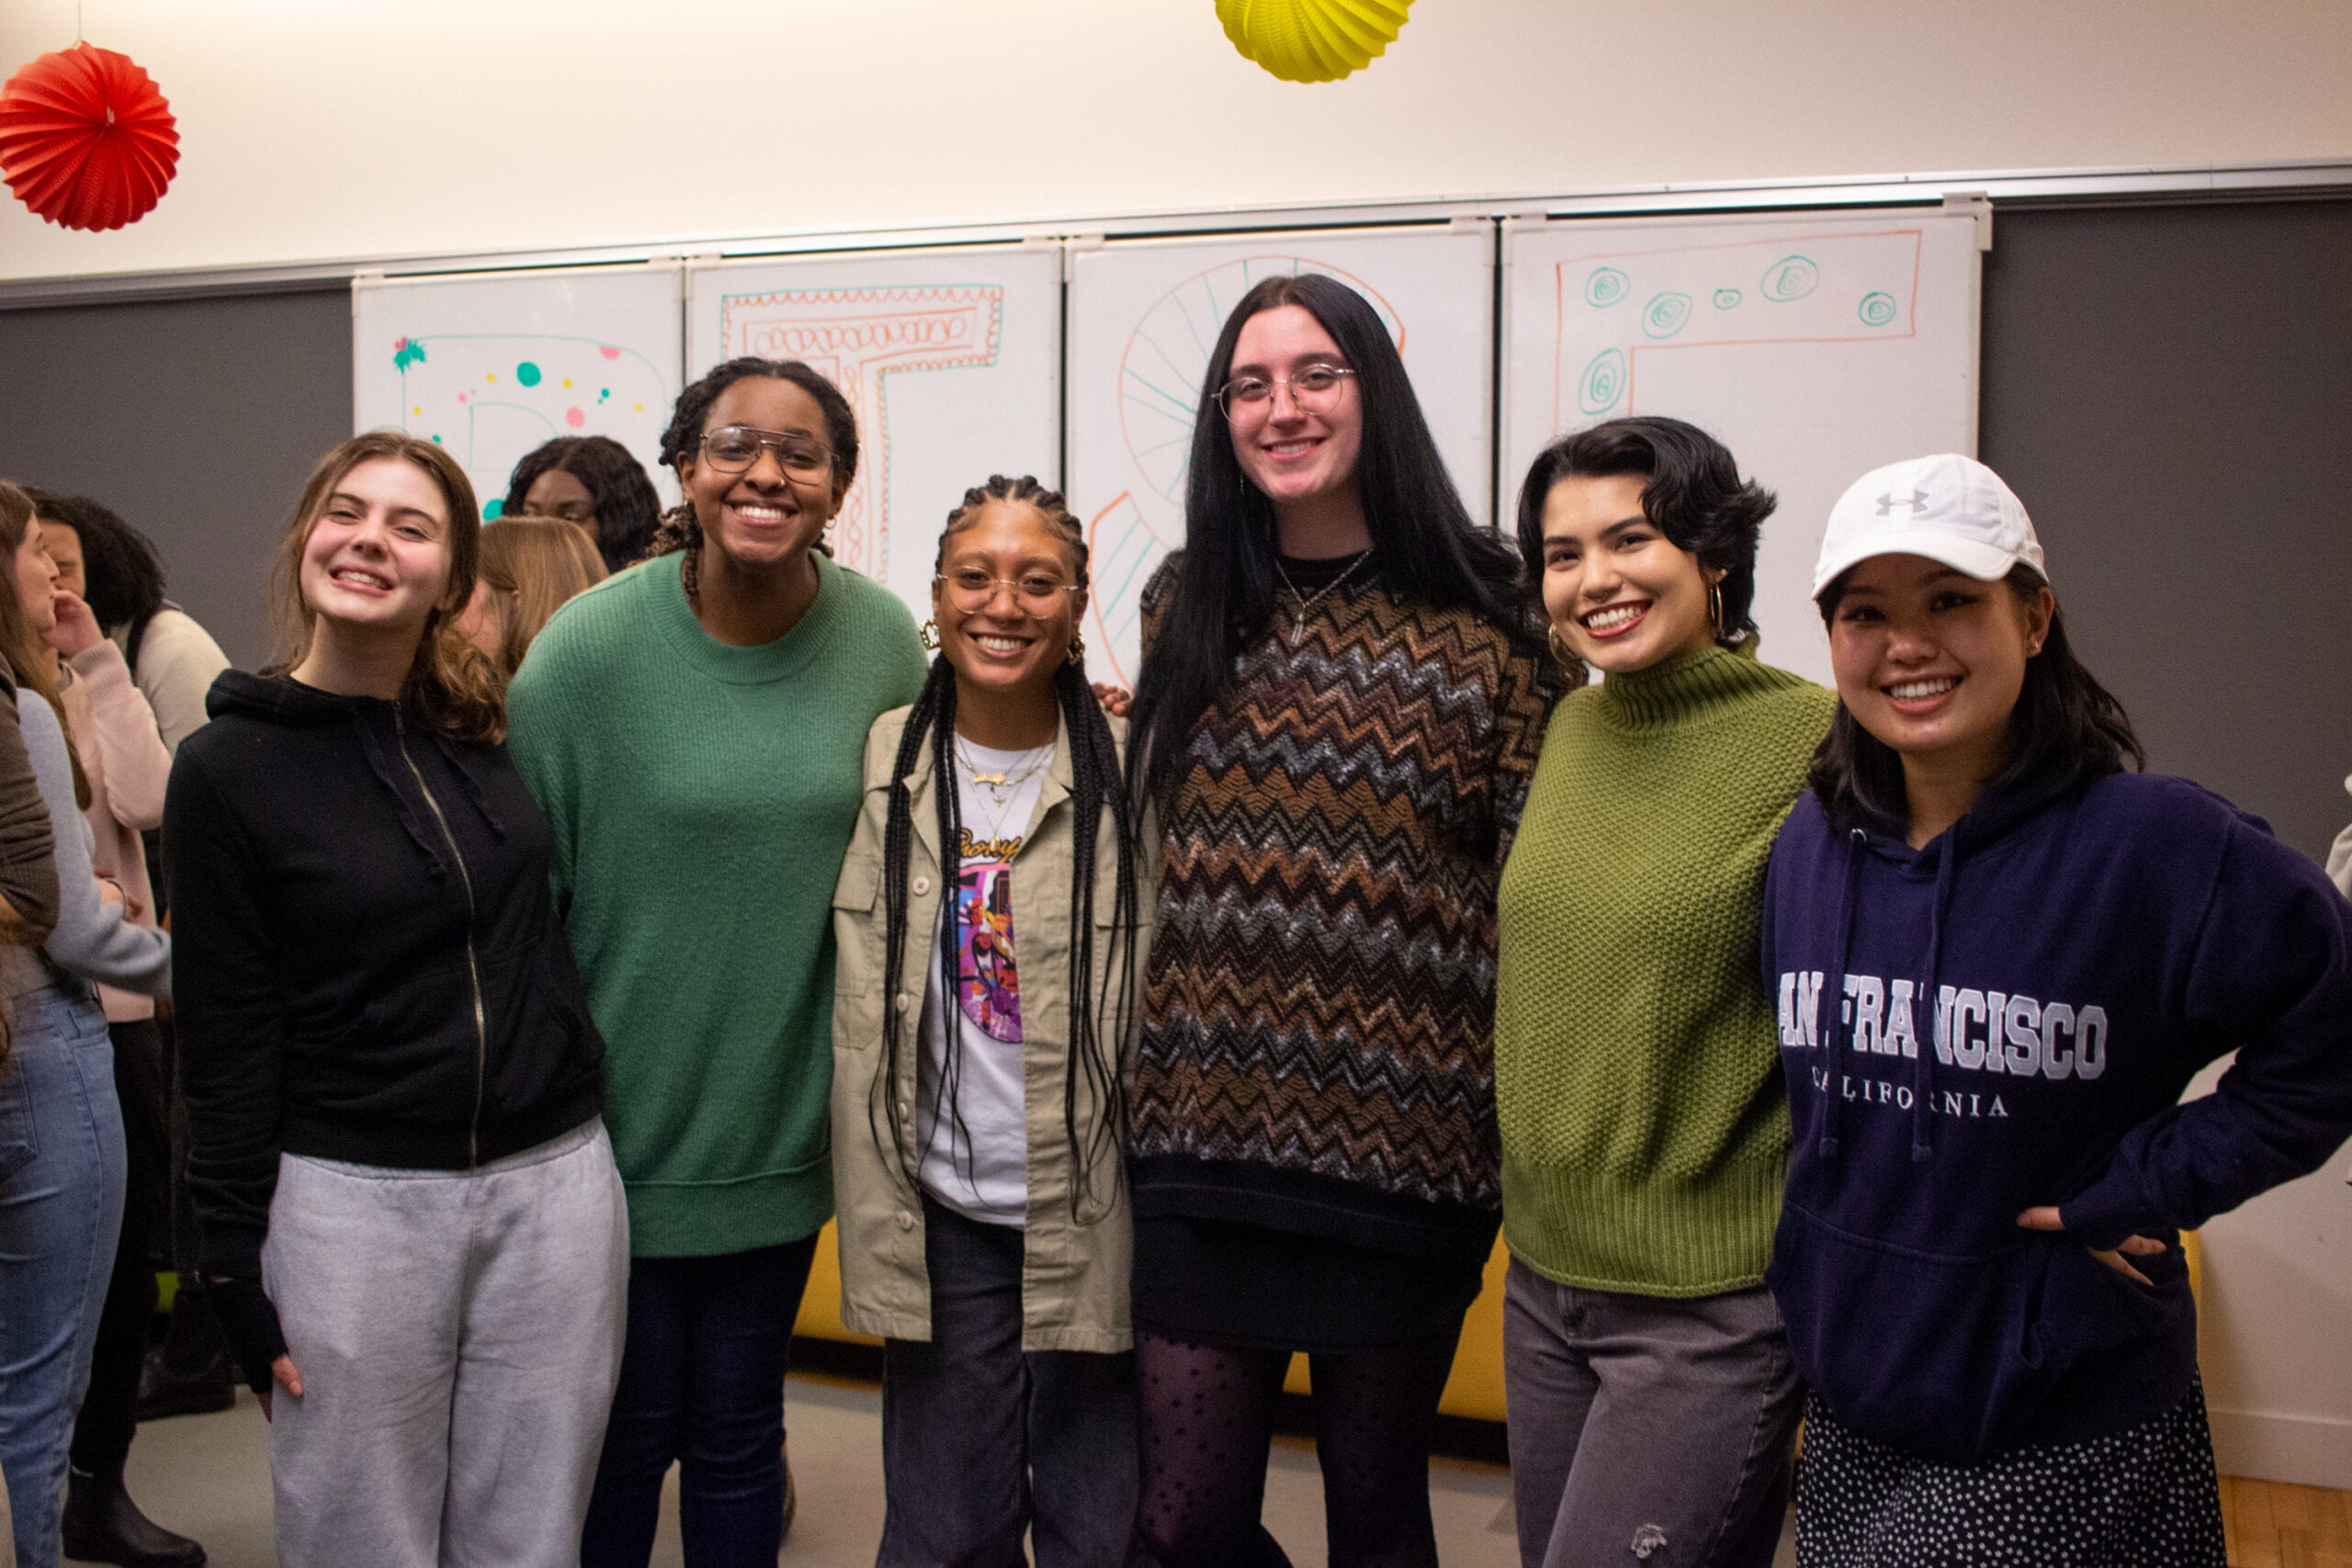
[{"xmin": 1520, "ymin": 413, "xmax": 1778, "ymax": 649}]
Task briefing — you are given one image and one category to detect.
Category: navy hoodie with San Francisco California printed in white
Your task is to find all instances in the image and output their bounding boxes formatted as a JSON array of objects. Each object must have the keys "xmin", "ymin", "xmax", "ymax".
[{"xmin": 1761, "ymin": 773, "xmax": 2352, "ymax": 1464}]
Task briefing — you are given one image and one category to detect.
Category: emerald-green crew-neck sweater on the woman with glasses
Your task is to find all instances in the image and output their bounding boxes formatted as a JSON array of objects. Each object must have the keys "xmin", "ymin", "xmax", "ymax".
[{"xmin": 508, "ymin": 555, "xmax": 924, "ymax": 1258}]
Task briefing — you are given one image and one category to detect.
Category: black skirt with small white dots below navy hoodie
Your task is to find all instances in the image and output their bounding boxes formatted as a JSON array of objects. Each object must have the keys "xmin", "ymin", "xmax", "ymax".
[{"xmin": 1797, "ymin": 1384, "xmax": 2225, "ymax": 1568}]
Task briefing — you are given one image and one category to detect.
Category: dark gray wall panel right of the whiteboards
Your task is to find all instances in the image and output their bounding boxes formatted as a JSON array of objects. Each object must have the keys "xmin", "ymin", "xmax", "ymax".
[{"xmin": 1981, "ymin": 200, "xmax": 2352, "ymax": 856}]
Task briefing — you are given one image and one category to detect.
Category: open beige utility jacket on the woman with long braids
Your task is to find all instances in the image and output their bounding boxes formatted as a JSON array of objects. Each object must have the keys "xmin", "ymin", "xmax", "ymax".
[{"xmin": 832, "ymin": 707, "xmax": 1152, "ymax": 1352}]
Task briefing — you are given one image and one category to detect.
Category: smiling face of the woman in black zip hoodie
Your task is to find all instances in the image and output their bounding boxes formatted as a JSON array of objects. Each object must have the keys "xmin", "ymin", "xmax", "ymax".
[{"xmin": 299, "ymin": 458, "xmax": 449, "ymax": 637}]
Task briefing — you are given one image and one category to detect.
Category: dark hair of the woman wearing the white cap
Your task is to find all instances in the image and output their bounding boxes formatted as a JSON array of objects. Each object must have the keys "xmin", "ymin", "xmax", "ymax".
[{"xmin": 1806, "ymin": 564, "xmax": 2147, "ymax": 832}]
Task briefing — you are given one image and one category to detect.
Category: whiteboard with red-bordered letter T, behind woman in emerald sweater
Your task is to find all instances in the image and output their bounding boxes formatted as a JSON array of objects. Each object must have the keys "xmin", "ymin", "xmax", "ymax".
[{"xmin": 687, "ymin": 247, "xmax": 1061, "ymax": 621}]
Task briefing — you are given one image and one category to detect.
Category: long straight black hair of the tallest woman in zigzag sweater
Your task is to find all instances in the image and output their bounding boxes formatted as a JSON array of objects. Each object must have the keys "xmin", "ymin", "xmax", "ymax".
[{"xmin": 1126, "ymin": 273, "xmax": 1541, "ymax": 799}]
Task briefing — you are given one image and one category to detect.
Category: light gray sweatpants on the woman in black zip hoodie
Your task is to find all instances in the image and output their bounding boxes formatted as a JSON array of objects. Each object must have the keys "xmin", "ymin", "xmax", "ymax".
[{"xmin": 261, "ymin": 1122, "xmax": 628, "ymax": 1568}]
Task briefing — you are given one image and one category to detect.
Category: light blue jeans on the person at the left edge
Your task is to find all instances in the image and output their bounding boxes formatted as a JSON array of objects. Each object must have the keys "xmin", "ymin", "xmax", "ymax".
[{"xmin": 0, "ymin": 980, "xmax": 122, "ymax": 1568}]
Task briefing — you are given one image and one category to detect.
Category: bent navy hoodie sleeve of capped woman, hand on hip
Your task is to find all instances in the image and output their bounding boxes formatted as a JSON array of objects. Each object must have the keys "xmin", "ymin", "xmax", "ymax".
[{"xmin": 2061, "ymin": 816, "xmax": 2352, "ymax": 1246}]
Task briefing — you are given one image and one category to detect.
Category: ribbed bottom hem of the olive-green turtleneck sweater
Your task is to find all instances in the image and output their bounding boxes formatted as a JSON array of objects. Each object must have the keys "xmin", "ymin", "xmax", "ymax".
[{"xmin": 1503, "ymin": 1149, "xmax": 1788, "ymax": 1298}]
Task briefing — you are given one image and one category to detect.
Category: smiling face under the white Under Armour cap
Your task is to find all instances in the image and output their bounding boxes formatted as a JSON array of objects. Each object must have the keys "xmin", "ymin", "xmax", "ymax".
[{"xmin": 1830, "ymin": 555, "xmax": 2055, "ymax": 781}]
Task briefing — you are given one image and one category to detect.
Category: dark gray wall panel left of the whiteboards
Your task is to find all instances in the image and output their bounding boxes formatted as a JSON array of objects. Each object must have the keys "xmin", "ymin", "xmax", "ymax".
[{"xmin": 0, "ymin": 289, "xmax": 350, "ymax": 668}]
